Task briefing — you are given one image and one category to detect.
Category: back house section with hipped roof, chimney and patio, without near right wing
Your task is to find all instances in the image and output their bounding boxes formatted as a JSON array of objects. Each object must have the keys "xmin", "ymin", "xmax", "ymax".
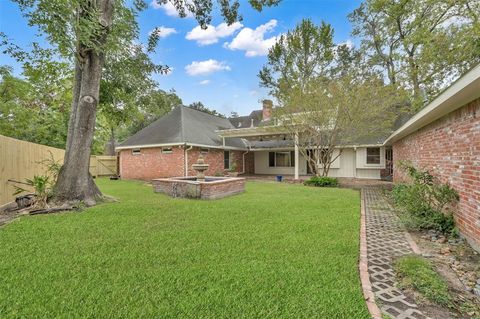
[{"xmin": 116, "ymin": 100, "xmax": 391, "ymax": 180}]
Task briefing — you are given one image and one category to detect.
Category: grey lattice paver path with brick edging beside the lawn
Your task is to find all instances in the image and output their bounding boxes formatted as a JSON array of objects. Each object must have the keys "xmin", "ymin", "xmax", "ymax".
[{"xmin": 359, "ymin": 187, "xmax": 428, "ymax": 319}]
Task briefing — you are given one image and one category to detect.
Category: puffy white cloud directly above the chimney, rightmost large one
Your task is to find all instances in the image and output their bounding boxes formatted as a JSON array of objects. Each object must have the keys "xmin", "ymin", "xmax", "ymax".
[{"xmin": 224, "ymin": 19, "xmax": 277, "ymax": 57}]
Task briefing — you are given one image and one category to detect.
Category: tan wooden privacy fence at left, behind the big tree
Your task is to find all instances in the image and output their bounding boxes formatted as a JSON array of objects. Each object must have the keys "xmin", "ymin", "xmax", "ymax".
[{"xmin": 0, "ymin": 135, "xmax": 117, "ymax": 205}]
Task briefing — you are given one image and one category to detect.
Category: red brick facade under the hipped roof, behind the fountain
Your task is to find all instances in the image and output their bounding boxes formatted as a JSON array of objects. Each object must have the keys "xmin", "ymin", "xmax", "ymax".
[{"xmin": 119, "ymin": 146, "xmax": 254, "ymax": 180}]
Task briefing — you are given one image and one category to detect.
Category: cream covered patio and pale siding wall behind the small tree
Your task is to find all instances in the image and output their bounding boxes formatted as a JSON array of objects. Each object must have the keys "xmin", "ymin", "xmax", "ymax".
[{"xmin": 216, "ymin": 125, "xmax": 392, "ymax": 184}]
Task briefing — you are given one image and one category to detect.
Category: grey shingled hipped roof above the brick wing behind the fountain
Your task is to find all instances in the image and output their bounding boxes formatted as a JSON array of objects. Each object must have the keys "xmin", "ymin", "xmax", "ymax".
[{"xmin": 119, "ymin": 106, "xmax": 246, "ymax": 148}]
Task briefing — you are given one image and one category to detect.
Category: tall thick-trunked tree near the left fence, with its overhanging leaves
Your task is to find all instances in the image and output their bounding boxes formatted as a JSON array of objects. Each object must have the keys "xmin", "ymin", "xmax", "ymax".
[{"xmin": 15, "ymin": 0, "xmax": 279, "ymax": 205}]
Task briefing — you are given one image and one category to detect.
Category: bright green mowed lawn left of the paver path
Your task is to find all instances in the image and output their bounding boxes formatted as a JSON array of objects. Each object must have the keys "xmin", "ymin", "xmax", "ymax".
[{"xmin": 0, "ymin": 179, "xmax": 369, "ymax": 318}]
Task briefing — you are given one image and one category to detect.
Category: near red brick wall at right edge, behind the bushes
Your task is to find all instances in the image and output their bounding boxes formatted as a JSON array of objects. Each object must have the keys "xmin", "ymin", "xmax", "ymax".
[{"xmin": 393, "ymin": 99, "xmax": 480, "ymax": 249}]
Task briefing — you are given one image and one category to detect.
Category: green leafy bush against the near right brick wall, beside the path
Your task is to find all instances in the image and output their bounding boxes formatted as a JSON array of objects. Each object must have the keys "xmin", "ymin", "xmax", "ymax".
[{"xmin": 392, "ymin": 163, "xmax": 459, "ymax": 234}]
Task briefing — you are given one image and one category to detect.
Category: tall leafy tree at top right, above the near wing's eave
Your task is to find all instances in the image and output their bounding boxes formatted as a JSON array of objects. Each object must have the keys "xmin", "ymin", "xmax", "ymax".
[{"xmin": 349, "ymin": 0, "xmax": 480, "ymax": 111}]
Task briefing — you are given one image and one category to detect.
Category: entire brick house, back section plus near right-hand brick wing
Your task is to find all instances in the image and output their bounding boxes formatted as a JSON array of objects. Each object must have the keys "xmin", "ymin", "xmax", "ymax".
[{"xmin": 116, "ymin": 65, "xmax": 480, "ymax": 250}]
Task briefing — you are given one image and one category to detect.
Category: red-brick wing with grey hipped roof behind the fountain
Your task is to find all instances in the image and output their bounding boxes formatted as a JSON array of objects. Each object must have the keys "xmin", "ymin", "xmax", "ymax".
[{"xmin": 116, "ymin": 106, "xmax": 254, "ymax": 180}]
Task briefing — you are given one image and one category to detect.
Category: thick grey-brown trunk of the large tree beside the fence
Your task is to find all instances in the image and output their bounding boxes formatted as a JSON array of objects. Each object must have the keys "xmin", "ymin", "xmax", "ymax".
[{"xmin": 53, "ymin": 0, "xmax": 113, "ymax": 206}]
